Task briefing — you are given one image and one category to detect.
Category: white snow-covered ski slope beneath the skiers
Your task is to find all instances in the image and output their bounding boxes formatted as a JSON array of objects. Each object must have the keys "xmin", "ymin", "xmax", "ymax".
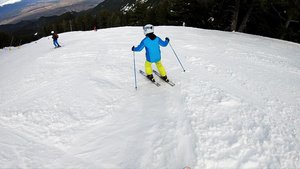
[{"xmin": 0, "ymin": 26, "xmax": 300, "ymax": 169}]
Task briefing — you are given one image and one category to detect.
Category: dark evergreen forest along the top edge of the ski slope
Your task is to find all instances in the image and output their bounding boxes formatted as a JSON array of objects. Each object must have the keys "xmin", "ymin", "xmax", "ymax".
[{"xmin": 0, "ymin": 0, "xmax": 300, "ymax": 47}]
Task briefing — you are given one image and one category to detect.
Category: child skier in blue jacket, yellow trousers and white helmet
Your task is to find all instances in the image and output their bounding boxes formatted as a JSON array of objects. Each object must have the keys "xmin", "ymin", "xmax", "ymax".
[{"xmin": 131, "ymin": 24, "xmax": 170, "ymax": 82}]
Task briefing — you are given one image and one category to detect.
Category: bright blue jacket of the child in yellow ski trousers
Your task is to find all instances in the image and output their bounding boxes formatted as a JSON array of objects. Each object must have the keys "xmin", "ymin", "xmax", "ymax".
[{"xmin": 133, "ymin": 36, "xmax": 169, "ymax": 63}]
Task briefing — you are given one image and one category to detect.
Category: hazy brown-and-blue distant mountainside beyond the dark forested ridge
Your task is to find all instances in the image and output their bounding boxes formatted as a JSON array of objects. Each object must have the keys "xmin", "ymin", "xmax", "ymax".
[{"xmin": 0, "ymin": 0, "xmax": 102, "ymax": 25}]
